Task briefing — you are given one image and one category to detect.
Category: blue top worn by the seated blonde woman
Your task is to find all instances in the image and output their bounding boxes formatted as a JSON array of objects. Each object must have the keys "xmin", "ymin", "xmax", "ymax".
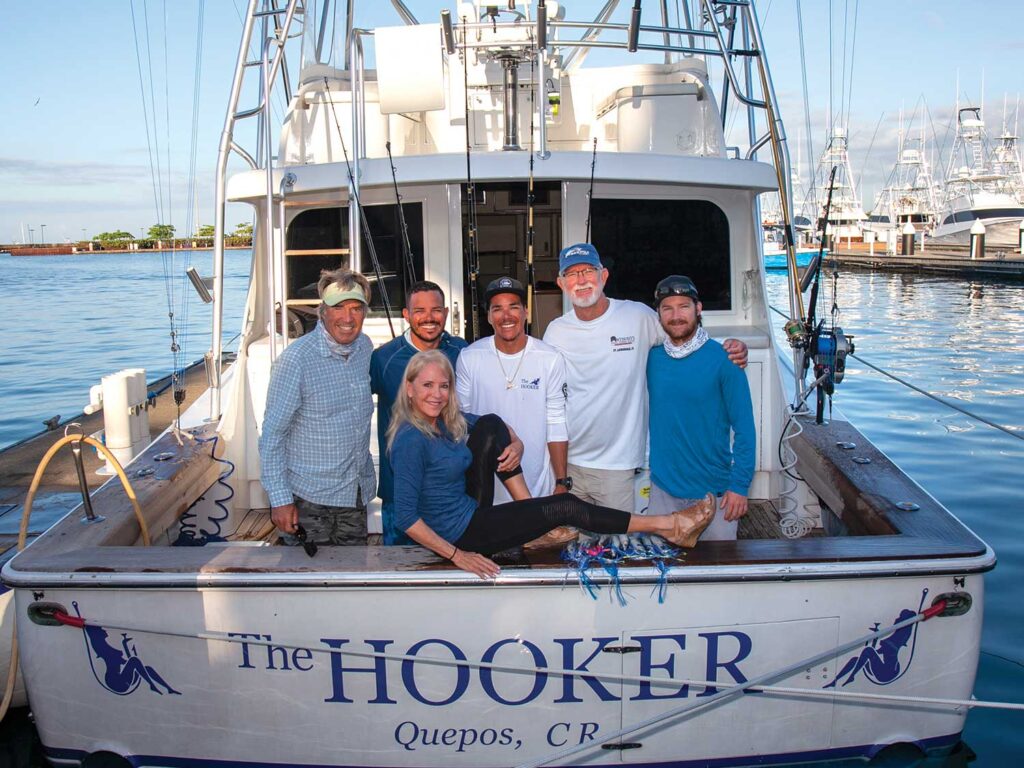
[{"xmin": 391, "ymin": 414, "xmax": 477, "ymax": 542}]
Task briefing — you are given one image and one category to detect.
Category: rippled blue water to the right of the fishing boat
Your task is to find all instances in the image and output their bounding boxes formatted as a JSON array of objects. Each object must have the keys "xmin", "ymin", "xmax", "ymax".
[{"xmin": 768, "ymin": 271, "xmax": 1024, "ymax": 766}]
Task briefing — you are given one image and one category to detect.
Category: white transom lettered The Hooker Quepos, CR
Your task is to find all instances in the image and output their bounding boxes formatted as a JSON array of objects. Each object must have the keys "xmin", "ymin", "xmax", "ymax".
[{"xmin": 18, "ymin": 566, "xmax": 983, "ymax": 766}]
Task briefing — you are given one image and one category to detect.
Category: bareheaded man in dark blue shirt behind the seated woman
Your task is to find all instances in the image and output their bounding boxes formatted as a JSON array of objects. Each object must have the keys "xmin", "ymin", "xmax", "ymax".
[{"xmin": 370, "ymin": 281, "xmax": 466, "ymax": 544}]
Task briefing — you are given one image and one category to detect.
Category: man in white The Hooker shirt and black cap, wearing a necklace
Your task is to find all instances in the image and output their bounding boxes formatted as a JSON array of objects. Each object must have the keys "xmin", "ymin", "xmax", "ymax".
[{"xmin": 456, "ymin": 278, "xmax": 571, "ymax": 504}]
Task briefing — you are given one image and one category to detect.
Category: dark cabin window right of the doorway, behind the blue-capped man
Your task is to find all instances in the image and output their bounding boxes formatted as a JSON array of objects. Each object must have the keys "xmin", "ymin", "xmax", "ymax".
[{"xmin": 591, "ymin": 199, "xmax": 732, "ymax": 310}]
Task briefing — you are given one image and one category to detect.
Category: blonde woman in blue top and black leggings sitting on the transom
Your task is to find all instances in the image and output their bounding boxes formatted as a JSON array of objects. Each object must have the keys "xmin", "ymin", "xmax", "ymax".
[{"xmin": 387, "ymin": 350, "xmax": 715, "ymax": 579}]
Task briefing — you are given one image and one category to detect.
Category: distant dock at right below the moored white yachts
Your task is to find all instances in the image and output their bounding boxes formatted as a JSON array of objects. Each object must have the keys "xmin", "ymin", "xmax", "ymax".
[{"xmin": 826, "ymin": 243, "xmax": 1024, "ymax": 280}]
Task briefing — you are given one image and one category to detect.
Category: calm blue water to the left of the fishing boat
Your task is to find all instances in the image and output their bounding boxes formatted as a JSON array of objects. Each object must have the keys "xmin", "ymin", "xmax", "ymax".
[{"xmin": 0, "ymin": 250, "xmax": 252, "ymax": 447}]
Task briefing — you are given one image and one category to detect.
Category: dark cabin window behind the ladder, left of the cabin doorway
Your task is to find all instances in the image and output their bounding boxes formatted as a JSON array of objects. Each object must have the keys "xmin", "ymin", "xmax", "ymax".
[{"xmin": 285, "ymin": 203, "xmax": 423, "ymax": 319}]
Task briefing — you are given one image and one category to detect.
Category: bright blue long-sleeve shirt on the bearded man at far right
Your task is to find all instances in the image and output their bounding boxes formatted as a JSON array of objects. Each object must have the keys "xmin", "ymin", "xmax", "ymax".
[{"xmin": 647, "ymin": 339, "xmax": 757, "ymax": 499}]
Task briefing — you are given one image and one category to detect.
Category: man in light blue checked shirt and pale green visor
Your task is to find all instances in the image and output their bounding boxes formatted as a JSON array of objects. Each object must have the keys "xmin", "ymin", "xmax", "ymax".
[{"xmin": 259, "ymin": 269, "xmax": 374, "ymax": 545}]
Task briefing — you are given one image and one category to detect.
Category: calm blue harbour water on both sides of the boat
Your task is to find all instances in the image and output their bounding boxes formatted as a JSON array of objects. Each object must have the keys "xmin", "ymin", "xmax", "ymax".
[{"xmin": 0, "ymin": 251, "xmax": 1024, "ymax": 766}]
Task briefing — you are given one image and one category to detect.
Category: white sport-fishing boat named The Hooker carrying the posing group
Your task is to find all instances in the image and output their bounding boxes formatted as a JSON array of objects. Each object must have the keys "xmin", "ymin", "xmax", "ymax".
[{"xmin": 3, "ymin": 0, "xmax": 995, "ymax": 766}]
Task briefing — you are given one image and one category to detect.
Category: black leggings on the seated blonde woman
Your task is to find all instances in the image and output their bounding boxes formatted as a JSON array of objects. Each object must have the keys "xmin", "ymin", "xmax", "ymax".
[{"xmin": 455, "ymin": 414, "xmax": 630, "ymax": 555}]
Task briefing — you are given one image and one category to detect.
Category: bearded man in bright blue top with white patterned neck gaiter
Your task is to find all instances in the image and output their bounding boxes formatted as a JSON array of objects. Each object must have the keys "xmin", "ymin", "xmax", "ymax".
[{"xmin": 647, "ymin": 274, "xmax": 757, "ymax": 541}]
